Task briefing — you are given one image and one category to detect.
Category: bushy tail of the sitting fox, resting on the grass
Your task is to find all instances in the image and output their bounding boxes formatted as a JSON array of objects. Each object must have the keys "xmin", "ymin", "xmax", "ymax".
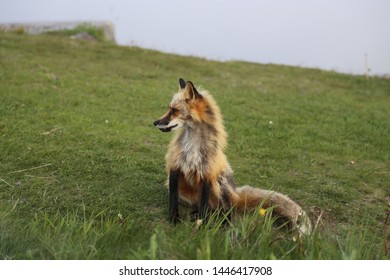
[{"xmin": 236, "ymin": 186, "xmax": 312, "ymax": 235}]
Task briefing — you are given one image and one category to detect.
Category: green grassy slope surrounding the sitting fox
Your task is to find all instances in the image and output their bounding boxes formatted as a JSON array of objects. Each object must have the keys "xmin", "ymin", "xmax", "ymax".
[{"xmin": 0, "ymin": 33, "xmax": 390, "ymax": 259}]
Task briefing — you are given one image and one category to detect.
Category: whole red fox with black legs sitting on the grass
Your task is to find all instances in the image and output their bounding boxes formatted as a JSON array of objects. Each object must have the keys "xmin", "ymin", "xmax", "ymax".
[{"xmin": 153, "ymin": 78, "xmax": 311, "ymax": 234}]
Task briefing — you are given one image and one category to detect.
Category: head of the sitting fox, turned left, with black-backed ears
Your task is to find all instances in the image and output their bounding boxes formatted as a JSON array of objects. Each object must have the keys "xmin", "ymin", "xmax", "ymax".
[{"xmin": 153, "ymin": 78, "xmax": 206, "ymax": 132}]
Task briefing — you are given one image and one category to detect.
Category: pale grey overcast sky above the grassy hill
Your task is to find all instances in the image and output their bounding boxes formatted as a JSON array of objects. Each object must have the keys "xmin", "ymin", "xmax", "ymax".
[{"xmin": 0, "ymin": 0, "xmax": 390, "ymax": 75}]
